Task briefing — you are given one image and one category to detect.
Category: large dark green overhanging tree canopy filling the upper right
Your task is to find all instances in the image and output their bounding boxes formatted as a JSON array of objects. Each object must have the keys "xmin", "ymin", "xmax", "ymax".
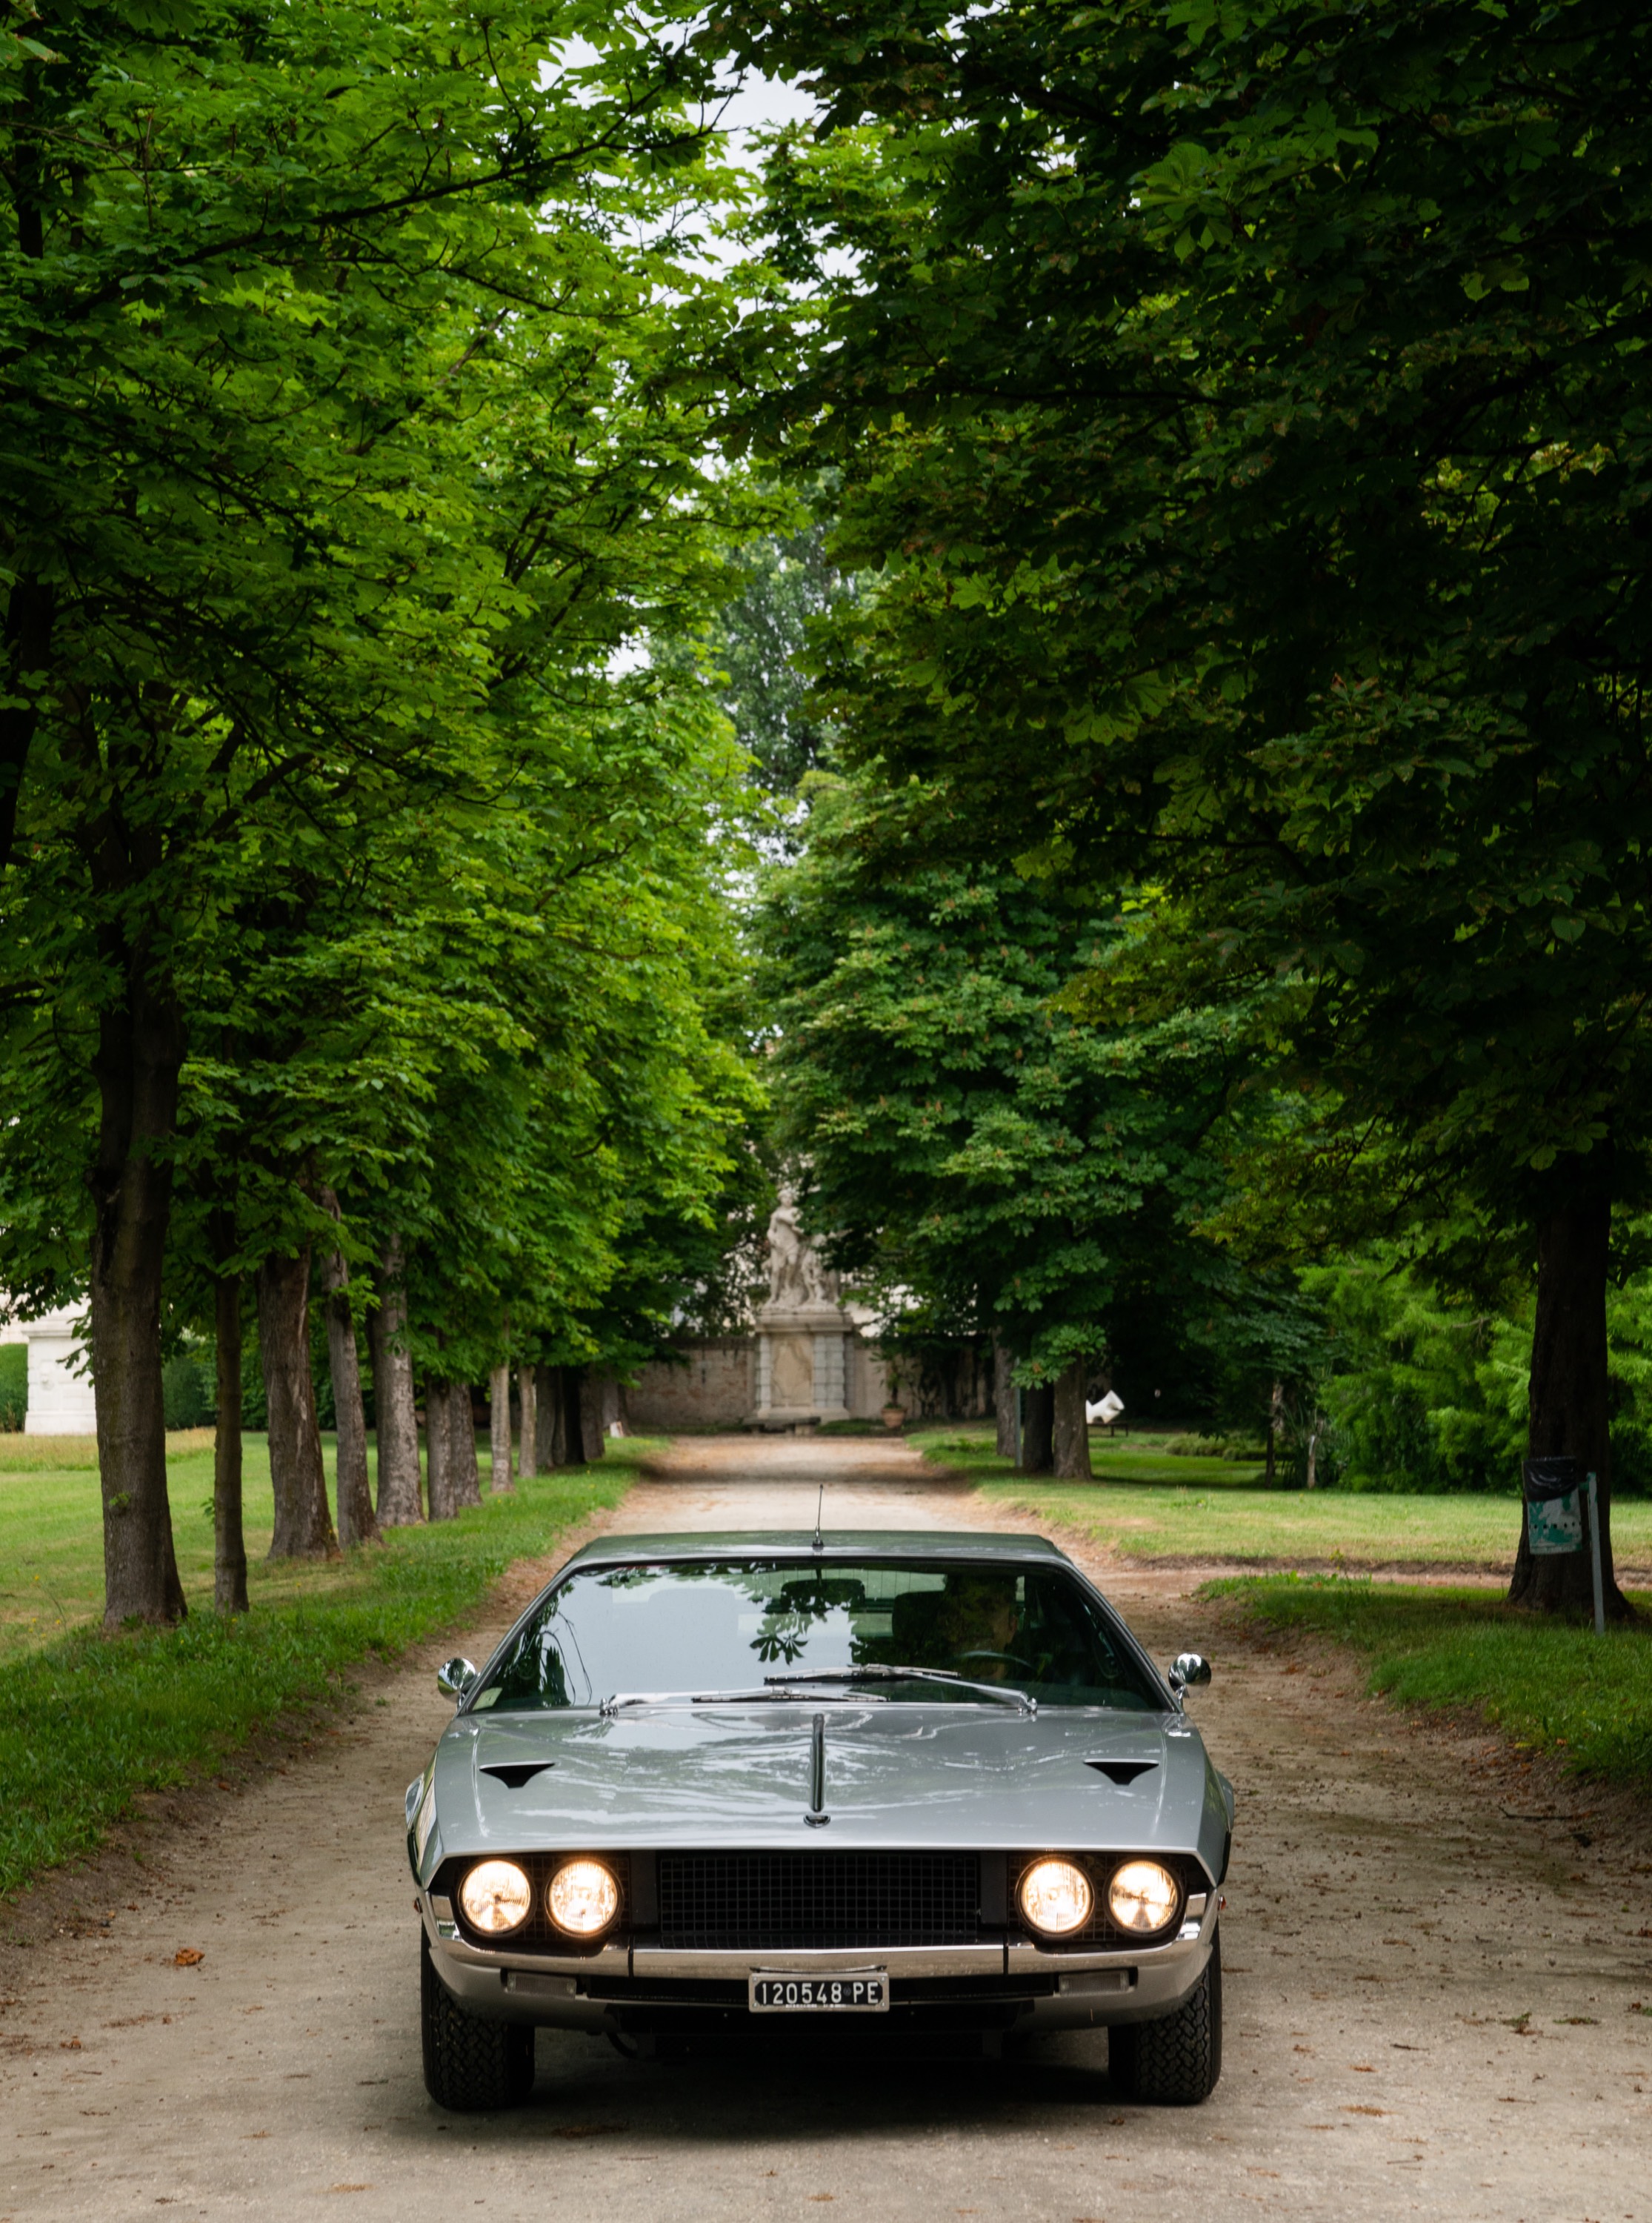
[{"xmin": 709, "ymin": 0, "xmax": 1652, "ymax": 1596}]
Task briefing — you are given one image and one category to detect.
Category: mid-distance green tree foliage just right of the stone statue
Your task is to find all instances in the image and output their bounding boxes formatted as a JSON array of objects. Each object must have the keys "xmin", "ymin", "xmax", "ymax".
[{"xmin": 760, "ymin": 782, "xmax": 1301, "ymax": 1425}]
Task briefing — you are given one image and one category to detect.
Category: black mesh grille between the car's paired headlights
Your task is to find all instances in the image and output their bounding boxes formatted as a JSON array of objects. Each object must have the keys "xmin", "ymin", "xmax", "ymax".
[{"xmin": 660, "ymin": 1852, "xmax": 981, "ymax": 1952}]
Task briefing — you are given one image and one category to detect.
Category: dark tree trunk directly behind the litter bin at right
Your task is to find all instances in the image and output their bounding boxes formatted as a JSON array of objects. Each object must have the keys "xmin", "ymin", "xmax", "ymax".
[{"xmin": 1510, "ymin": 1196, "xmax": 1634, "ymax": 1621}]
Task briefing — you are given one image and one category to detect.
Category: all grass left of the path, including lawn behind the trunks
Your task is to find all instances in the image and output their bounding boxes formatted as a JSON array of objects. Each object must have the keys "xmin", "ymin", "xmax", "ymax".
[{"xmin": 0, "ymin": 1434, "xmax": 658, "ymax": 1896}]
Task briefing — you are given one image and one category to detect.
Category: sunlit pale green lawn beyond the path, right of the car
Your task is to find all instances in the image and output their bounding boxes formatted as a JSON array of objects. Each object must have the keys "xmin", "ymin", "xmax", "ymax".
[{"xmin": 910, "ymin": 1423, "xmax": 1652, "ymax": 1569}]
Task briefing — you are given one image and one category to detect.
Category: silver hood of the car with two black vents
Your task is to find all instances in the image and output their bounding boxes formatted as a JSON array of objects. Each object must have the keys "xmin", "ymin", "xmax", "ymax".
[{"xmin": 420, "ymin": 1701, "xmax": 1232, "ymax": 1874}]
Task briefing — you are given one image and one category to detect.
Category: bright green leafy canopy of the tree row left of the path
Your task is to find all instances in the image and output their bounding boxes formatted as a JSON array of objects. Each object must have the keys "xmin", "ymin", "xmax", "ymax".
[{"xmin": 0, "ymin": 0, "xmax": 747, "ymax": 1623}]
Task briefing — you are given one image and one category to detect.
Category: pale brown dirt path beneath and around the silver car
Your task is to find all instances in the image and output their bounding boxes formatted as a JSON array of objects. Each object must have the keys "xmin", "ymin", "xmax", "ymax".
[{"xmin": 0, "ymin": 1438, "xmax": 1652, "ymax": 2223}]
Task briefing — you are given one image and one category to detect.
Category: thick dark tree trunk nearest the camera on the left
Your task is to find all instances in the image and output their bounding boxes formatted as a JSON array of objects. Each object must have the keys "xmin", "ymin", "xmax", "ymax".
[{"xmin": 89, "ymin": 949, "xmax": 187, "ymax": 1629}]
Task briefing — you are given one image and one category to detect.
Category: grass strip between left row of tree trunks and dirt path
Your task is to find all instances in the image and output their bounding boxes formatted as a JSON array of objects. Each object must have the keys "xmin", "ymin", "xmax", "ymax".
[{"xmin": 0, "ymin": 1438, "xmax": 658, "ymax": 1896}]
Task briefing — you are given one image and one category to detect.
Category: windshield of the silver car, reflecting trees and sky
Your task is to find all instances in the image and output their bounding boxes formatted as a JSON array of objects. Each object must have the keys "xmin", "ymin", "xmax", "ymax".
[{"xmin": 471, "ymin": 1558, "xmax": 1165, "ymax": 1714}]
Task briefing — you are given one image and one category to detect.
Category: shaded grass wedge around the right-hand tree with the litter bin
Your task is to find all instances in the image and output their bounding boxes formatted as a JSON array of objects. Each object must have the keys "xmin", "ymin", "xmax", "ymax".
[{"xmin": 1201, "ymin": 1574, "xmax": 1652, "ymax": 1790}]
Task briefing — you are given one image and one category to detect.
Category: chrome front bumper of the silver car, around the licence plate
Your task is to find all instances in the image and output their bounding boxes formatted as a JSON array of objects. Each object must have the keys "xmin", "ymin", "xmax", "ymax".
[{"xmin": 420, "ymin": 1892, "xmax": 1221, "ymax": 2036}]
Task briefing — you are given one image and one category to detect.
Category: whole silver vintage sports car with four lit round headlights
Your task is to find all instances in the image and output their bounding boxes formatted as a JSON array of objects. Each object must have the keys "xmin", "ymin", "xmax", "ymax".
[{"xmin": 407, "ymin": 1532, "xmax": 1234, "ymax": 2107}]
